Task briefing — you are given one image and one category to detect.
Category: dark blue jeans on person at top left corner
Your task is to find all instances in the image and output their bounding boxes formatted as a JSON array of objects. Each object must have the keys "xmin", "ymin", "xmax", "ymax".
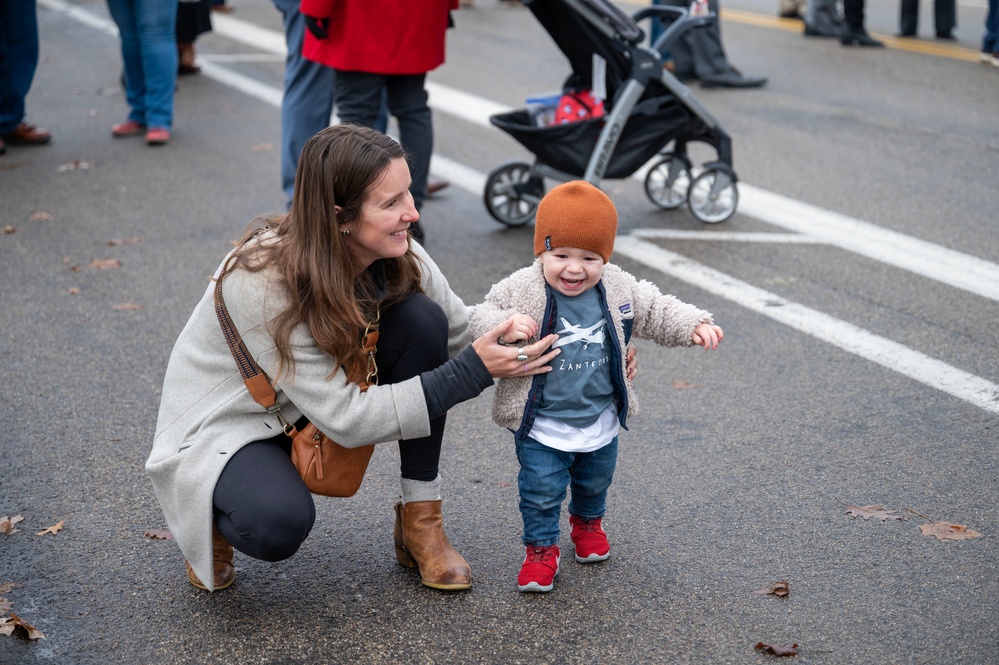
[{"xmin": 0, "ymin": 0, "xmax": 38, "ymax": 136}]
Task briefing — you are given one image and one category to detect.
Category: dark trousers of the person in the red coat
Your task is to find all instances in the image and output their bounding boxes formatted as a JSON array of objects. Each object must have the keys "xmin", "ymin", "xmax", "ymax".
[{"xmin": 336, "ymin": 71, "xmax": 434, "ymax": 210}]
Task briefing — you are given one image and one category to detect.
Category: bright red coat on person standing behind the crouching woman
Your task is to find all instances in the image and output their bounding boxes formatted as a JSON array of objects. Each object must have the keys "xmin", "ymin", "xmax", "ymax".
[{"xmin": 301, "ymin": 0, "xmax": 458, "ymax": 74}]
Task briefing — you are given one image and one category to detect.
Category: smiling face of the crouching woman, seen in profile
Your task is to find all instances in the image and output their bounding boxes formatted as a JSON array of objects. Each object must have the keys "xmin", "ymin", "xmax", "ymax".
[{"xmin": 344, "ymin": 157, "xmax": 420, "ymax": 267}]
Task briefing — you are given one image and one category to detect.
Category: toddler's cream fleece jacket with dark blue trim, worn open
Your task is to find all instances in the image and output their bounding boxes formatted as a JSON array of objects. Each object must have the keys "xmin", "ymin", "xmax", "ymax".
[{"xmin": 470, "ymin": 260, "xmax": 713, "ymax": 432}]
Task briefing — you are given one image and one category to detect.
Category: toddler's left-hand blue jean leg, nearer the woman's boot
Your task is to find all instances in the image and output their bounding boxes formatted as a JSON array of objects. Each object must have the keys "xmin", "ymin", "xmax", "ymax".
[{"xmin": 516, "ymin": 436, "xmax": 574, "ymax": 547}]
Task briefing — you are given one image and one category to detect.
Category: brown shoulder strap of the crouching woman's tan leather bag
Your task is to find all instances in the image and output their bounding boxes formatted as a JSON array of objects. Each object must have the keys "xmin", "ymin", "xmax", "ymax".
[{"xmin": 214, "ymin": 263, "xmax": 381, "ymax": 436}]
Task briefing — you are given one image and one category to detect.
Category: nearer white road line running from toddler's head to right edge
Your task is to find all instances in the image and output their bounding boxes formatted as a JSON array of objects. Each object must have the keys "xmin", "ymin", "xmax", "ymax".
[{"xmin": 614, "ymin": 236, "xmax": 999, "ymax": 414}]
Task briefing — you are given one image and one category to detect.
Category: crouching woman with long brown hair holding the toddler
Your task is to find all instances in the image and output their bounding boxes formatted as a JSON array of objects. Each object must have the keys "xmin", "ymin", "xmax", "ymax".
[{"xmin": 146, "ymin": 125, "xmax": 572, "ymax": 591}]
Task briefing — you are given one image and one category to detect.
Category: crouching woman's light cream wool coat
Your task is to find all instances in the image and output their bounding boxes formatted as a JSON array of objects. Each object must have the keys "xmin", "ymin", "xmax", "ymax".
[{"xmin": 146, "ymin": 243, "xmax": 472, "ymax": 588}]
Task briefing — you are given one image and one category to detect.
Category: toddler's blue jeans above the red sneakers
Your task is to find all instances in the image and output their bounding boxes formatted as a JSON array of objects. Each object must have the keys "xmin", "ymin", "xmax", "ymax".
[{"xmin": 516, "ymin": 436, "xmax": 617, "ymax": 547}]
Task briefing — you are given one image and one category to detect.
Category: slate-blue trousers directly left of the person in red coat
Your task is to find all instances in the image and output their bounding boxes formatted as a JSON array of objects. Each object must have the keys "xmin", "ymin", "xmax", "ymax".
[{"xmin": 273, "ymin": 0, "xmax": 335, "ymax": 207}]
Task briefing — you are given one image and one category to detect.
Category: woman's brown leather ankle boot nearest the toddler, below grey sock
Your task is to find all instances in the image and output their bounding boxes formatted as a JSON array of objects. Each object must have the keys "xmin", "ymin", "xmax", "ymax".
[{"xmin": 392, "ymin": 501, "xmax": 472, "ymax": 591}]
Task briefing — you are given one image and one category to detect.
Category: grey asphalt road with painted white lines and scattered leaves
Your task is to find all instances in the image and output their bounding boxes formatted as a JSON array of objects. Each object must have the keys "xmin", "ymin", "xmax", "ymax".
[{"xmin": 0, "ymin": 0, "xmax": 999, "ymax": 665}]
